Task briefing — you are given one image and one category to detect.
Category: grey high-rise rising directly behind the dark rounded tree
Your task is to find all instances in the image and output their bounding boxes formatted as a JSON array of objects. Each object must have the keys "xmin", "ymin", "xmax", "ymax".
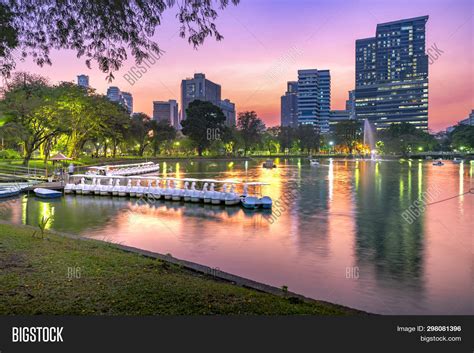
[{"xmin": 181, "ymin": 73, "xmax": 221, "ymax": 120}]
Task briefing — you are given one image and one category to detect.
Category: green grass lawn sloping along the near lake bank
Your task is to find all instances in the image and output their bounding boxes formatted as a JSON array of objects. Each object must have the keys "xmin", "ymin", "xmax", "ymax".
[{"xmin": 0, "ymin": 224, "xmax": 356, "ymax": 315}]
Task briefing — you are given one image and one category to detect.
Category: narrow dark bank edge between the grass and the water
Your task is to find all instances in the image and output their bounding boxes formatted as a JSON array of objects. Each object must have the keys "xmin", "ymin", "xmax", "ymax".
[{"xmin": 0, "ymin": 220, "xmax": 366, "ymax": 315}]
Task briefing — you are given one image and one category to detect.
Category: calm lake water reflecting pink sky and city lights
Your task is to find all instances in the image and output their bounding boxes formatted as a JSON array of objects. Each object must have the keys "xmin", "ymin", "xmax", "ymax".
[{"xmin": 0, "ymin": 159, "xmax": 474, "ymax": 314}]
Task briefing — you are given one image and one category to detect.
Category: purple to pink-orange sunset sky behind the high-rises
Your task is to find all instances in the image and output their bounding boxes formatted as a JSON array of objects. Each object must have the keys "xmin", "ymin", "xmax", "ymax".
[{"xmin": 12, "ymin": 0, "xmax": 474, "ymax": 131}]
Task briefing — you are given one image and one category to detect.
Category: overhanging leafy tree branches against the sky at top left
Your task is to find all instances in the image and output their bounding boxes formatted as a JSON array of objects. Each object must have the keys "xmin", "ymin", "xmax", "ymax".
[{"xmin": 0, "ymin": 0, "xmax": 239, "ymax": 79}]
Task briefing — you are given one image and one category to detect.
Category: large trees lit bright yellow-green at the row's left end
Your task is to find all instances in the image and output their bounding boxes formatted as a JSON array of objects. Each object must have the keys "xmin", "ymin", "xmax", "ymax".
[{"xmin": 0, "ymin": 73, "xmax": 130, "ymax": 165}]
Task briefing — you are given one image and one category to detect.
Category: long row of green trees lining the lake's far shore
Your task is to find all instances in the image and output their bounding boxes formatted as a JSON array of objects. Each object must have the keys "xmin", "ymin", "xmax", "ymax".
[{"xmin": 0, "ymin": 73, "xmax": 474, "ymax": 165}]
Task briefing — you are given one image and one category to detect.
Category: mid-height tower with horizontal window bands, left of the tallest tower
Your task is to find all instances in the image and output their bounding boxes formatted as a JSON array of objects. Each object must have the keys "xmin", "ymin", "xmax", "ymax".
[{"xmin": 298, "ymin": 69, "xmax": 331, "ymax": 133}]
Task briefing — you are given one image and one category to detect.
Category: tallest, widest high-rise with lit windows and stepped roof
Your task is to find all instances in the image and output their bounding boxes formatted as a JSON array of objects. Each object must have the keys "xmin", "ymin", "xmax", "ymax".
[{"xmin": 355, "ymin": 16, "xmax": 428, "ymax": 129}]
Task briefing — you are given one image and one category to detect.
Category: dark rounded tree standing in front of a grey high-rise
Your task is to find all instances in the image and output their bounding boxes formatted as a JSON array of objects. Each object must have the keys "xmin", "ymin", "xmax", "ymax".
[{"xmin": 181, "ymin": 100, "xmax": 226, "ymax": 157}]
